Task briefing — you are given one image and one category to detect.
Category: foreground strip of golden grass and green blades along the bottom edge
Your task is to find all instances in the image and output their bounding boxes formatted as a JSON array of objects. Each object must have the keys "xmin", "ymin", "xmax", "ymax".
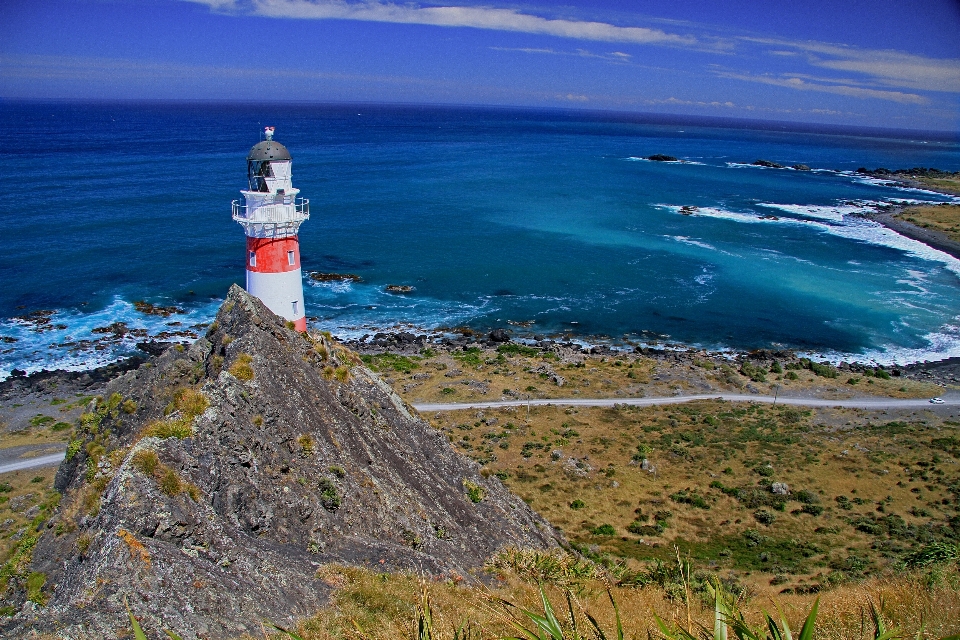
[{"xmin": 201, "ymin": 550, "xmax": 960, "ymax": 640}]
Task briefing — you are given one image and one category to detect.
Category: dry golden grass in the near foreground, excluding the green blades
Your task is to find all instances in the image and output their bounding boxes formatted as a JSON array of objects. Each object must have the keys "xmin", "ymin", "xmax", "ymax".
[{"xmin": 238, "ymin": 566, "xmax": 960, "ymax": 640}]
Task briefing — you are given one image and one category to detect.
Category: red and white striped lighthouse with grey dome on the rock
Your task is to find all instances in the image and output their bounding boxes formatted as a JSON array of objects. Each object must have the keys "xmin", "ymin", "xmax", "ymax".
[{"xmin": 233, "ymin": 127, "xmax": 310, "ymax": 331}]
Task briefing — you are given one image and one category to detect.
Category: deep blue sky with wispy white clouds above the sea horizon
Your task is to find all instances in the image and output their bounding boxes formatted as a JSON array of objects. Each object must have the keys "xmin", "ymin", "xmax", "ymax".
[{"xmin": 0, "ymin": 0, "xmax": 960, "ymax": 132}]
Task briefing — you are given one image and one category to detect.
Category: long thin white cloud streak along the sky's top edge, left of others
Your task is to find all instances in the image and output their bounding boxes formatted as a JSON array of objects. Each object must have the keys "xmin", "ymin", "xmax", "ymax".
[{"xmin": 188, "ymin": 0, "xmax": 717, "ymax": 49}]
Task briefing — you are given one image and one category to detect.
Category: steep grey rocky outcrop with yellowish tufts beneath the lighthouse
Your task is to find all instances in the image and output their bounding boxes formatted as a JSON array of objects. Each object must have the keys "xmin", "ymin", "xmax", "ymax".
[{"xmin": 4, "ymin": 287, "xmax": 557, "ymax": 638}]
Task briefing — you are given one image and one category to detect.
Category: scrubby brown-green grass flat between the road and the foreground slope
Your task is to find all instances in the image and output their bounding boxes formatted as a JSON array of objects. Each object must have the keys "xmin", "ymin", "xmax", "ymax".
[{"xmin": 431, "ymin": 401, "xmax": 960, "ymax": 596}]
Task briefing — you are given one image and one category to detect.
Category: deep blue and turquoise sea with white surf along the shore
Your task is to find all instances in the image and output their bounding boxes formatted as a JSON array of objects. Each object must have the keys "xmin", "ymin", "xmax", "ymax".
[{"xmin": 0, "ymin": 103, "xmax": 960, "ymax": 376}]
